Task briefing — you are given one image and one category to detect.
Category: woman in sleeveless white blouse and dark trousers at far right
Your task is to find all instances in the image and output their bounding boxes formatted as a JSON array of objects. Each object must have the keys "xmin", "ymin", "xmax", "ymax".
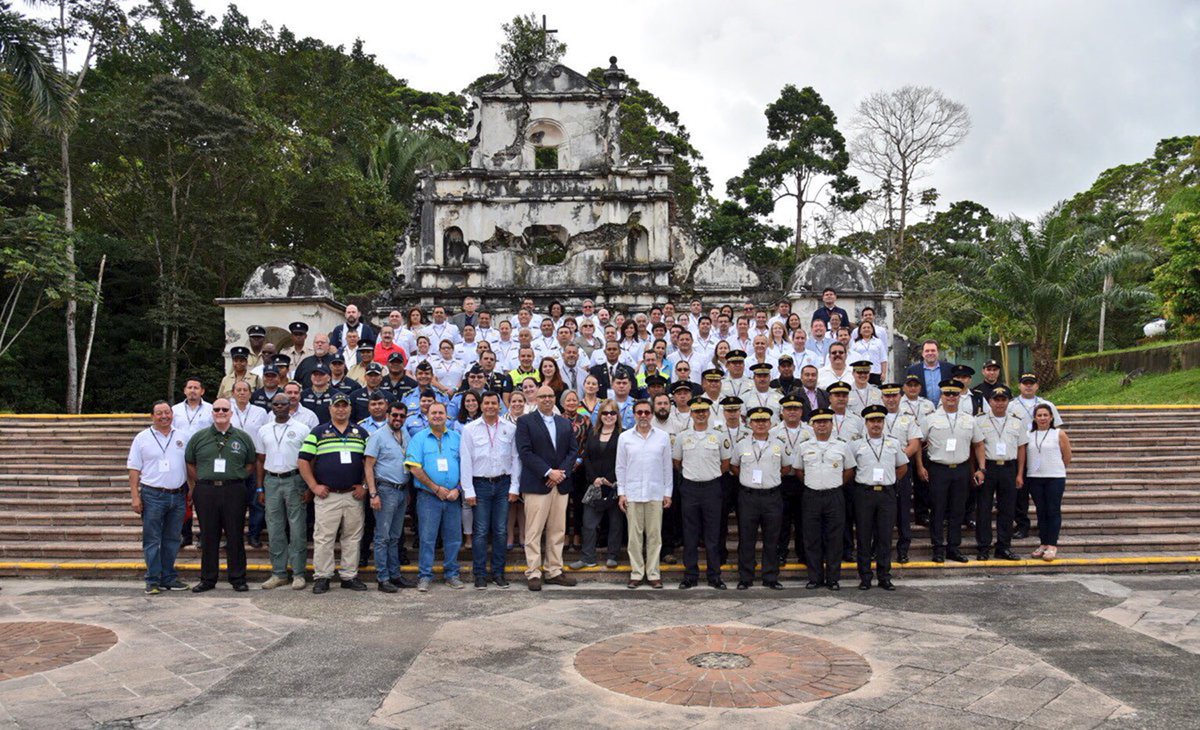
[{"xmin": 1016, "ymin": 403, "xmax": 1070, "ymax": 562}]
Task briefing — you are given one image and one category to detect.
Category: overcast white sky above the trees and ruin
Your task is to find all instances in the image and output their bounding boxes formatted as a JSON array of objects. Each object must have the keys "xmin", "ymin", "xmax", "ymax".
[{"xmin": 79, "ymin": 0, "xmax": 1200, "ymax": 216}]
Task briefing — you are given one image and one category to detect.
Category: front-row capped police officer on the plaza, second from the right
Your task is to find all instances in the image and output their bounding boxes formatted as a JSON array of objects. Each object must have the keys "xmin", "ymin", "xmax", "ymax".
[{"xmin": 794, "ymin": 408, "xmax": 850, "ymax": 591}]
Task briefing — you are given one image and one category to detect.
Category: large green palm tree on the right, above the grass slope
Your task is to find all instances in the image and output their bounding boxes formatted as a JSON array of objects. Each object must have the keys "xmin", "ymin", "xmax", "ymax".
[{"xmin": 960, "ymin": 205, "xmax": 1151, "ymax": 385}]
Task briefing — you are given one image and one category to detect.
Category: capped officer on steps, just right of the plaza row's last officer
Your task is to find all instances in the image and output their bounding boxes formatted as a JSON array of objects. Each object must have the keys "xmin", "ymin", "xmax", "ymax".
[{"xmin": 917, "ymin": 378, "xmax": 982, "ymax": 563}]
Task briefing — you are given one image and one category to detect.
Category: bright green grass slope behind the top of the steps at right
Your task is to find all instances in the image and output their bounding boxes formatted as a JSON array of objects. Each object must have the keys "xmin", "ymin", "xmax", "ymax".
[{"xmin": 1044, "ymin": 370, "xmax": 1200, "ymax": 406}]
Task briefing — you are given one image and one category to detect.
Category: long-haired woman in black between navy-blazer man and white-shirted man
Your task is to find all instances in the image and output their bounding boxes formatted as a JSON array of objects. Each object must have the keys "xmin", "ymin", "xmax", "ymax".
[{"xmin": 569, "ymin": 400, "xmax": 625, "ymax": 570}]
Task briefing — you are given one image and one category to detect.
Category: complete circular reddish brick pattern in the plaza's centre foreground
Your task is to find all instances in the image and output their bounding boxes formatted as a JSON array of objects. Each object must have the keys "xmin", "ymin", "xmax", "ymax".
[{"xmin": 575, "ymin": 626, "xmax": 871, "ymax": 707}]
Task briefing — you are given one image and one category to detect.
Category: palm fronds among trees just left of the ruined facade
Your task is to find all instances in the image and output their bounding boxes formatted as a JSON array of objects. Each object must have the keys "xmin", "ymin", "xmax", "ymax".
[{"xmin": 362, "ymin": 124, "xmax": 467, "ymax": 205}]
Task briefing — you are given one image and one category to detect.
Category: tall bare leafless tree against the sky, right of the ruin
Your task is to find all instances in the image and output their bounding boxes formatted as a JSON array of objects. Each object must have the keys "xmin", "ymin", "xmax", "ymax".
[{"xmin": 850, "ymin": 85, "xmax": 971, "ymax": 279}]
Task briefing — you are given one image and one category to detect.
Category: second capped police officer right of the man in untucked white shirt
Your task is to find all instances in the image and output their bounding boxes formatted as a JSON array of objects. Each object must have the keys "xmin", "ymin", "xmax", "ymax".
[{"xmin": 732, "ymin": 407, "xmax": 792, "ymax": 591}]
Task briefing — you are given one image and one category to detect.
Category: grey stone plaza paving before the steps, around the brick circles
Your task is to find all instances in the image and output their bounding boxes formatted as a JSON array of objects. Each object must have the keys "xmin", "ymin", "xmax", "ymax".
[{"xmin": 0, "ymin": 575, "xmax": 1200, "ymax": 729}]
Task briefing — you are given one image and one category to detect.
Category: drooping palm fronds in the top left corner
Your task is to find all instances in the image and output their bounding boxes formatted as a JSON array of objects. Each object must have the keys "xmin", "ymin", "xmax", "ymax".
[{"xmin": 0, "ymin": 2, "xmax": 74, "ymax": 149}]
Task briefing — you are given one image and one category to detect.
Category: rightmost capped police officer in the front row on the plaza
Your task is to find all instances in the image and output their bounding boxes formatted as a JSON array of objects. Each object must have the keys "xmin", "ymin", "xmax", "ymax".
[{"xmin": 846, "ymin": 406, "xmax": 908, "ymax": 591}]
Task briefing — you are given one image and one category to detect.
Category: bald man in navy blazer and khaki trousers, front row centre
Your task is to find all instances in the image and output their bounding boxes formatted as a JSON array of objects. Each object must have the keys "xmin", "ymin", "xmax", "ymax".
[{"xmin": 515, "ymin": 385, "xmax": 578, "ymax": 591}]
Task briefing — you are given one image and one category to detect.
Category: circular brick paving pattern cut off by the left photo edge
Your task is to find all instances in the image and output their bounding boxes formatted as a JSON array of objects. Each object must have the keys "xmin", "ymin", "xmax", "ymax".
[{"xmin": 0, "ymin": 621, "xmax": 116, "ymax": 682}]
